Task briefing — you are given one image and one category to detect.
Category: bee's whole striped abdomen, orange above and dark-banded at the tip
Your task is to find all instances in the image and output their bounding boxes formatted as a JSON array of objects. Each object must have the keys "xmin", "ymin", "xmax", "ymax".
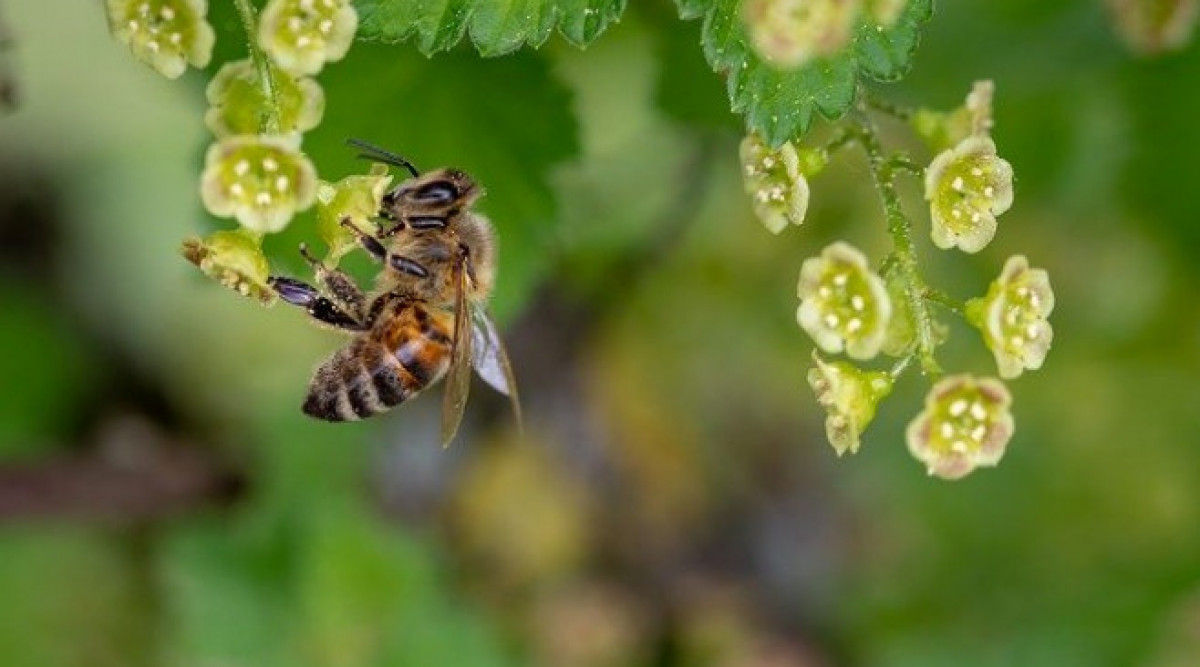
[{"xmin": 304, "ymin": 302, "xmax": 454, "ymax": 421}]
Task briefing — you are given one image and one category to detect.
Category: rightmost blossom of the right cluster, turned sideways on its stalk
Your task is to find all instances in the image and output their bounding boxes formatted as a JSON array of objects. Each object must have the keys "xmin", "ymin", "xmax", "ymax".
[{"xmin": 967, "ymin": 254, "xmax": 1054, "ymax": 379}]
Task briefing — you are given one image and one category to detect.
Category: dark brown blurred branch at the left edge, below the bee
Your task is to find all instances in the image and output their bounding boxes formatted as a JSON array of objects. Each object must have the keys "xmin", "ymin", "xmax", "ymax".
[{"xmin": 0, "ymin": 416, "xmax": 241, "ymax": 523}]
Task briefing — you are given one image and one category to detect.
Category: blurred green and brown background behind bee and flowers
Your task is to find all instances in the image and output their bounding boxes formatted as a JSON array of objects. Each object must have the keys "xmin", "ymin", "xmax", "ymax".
[{"xmin": 0, "ymin": 0, "xmax": 1200, "ymax": 667}]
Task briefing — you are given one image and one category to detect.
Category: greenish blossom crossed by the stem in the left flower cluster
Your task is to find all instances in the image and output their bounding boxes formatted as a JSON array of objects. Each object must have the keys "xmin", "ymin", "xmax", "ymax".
[{"xmin": 204, "ymin": 59, "xmax": 325, "ymax": 137}]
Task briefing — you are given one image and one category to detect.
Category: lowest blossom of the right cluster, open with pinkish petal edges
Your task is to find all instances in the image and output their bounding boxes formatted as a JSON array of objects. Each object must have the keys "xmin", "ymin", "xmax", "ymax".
[{"xmin": 906, "ymin": 375, "xmax": 1014, "ymax": 480}]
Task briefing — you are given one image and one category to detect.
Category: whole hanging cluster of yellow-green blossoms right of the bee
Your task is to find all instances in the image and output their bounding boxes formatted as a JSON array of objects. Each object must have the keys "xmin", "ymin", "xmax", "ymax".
[{"xmin": 758, "ymin": 83, "xmax": 1054, "ymax": 480}]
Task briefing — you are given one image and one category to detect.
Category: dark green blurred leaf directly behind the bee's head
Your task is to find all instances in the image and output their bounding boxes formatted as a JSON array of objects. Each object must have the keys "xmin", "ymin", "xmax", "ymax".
[{"xmin": 294, "ymin": 43, "xmax": 578, "ymax": 319}]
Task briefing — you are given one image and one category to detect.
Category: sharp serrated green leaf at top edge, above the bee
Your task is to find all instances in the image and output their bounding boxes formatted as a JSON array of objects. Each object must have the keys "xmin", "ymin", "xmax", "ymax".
[{"xmin": 355, "ymin": 0, "xmax": 625, "ymax": 55}]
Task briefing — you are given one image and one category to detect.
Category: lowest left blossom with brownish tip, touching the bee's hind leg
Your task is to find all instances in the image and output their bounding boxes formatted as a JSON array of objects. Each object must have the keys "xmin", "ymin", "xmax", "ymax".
[{"xmin": 181, "ymin": 229, "xmax": 275, "ymax": 305}]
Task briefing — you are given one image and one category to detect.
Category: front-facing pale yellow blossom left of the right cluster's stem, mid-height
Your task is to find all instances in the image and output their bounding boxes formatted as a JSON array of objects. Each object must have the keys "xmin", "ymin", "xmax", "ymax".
[{"xmin": 796, "ymin": 241, "xmax": 892, "ymax": 359}]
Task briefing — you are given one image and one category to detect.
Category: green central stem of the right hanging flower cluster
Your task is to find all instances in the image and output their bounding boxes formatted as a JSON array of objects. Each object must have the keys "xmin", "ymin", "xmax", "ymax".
[{"xmin": 854, "ymin": 113, "xmax": 942, "ymax": 378}]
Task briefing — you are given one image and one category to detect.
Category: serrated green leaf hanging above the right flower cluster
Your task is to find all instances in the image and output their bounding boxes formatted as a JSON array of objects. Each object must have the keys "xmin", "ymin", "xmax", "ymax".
[{"xmin": 676, "ymin": 0, "xmax": 932, "ymax": 146}]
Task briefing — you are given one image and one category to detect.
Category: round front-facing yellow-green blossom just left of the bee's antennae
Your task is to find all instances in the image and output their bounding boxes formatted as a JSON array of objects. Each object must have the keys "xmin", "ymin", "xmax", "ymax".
[{"xmin": 200, "ymin": 134, "xmax": 317, "ymax": 233}]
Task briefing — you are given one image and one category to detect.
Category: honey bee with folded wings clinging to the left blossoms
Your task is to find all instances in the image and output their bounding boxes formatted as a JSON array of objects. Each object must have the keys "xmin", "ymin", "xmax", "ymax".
[{"xmin": 269, "ymin": 140, "xmax": 521, "ymax": 445}]
